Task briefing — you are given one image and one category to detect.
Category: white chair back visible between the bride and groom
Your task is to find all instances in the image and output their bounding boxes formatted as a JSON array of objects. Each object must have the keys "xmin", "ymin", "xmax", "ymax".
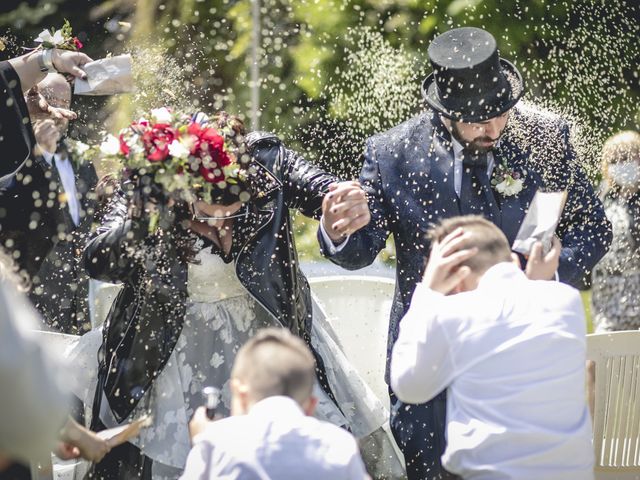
[{"xmin": 309, "ymin": 275, "xmax": 395, "ymax": 405}]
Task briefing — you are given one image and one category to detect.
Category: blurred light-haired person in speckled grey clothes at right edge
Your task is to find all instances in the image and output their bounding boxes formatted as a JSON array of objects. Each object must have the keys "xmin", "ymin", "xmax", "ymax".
[{"xmin": 591, "ymin": 131, "xmax": 640, "ymax": 332}]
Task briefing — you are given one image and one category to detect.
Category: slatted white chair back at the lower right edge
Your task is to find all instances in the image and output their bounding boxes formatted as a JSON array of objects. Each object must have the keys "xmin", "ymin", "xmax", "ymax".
[{"xmin": 587, "ymin": 331, "xmax": 640, "ymax": 480}]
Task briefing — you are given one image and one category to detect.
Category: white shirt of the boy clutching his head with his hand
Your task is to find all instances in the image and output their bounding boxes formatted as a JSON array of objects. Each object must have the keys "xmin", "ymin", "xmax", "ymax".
[{"xmin": 391, "ymin": 263, "xmax": 593, "ymax": 480}]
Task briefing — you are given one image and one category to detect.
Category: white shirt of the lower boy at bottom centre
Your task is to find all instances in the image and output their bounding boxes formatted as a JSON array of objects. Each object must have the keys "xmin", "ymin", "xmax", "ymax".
[{"xmin": 181, "ymin": 396, "xmax": 368, "ymax": 480}]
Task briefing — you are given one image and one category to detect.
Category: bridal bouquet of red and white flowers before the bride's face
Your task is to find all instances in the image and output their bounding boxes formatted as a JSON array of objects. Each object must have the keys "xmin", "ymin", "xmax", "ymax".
[{"xmin": 100, "ymin": 107, "xmax": 249, "ymax": 203}]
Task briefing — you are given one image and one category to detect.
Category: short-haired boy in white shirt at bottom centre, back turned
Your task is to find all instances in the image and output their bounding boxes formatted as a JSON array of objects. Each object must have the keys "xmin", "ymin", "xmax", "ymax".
[{"xmin": 182, "ymin": 328, "xmax": 369, "ymax": 480}]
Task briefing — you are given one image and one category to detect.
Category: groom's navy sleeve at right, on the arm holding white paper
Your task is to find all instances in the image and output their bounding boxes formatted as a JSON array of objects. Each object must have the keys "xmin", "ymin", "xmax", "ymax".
[{"xmin": 556, "ymin": 124, "xmax": 613, "ymax": 289}]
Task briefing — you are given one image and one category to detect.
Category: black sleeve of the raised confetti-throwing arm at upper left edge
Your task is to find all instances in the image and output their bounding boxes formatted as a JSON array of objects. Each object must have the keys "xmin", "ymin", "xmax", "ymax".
[{"xmin": 0, "ymin": 61, "xmax": 35, "ymax": 180}]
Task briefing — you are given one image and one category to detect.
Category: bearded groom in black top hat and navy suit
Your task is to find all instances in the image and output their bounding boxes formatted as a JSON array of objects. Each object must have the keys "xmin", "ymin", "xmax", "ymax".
[{"xmin": 319, "ymin": 28, "xmax": 611, "ymax": 479}]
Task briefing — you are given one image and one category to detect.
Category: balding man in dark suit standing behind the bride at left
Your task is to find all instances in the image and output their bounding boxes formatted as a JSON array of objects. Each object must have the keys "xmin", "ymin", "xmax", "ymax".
[{"xmin": 29, "ymin": 74, "xmax": 98, "ymax": 334}]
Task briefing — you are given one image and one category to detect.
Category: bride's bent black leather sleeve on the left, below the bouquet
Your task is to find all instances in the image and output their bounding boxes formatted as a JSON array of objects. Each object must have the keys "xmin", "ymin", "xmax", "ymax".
[{"xmin": 84, "ymin": 192, "xmax": 148, "ymax": 283}]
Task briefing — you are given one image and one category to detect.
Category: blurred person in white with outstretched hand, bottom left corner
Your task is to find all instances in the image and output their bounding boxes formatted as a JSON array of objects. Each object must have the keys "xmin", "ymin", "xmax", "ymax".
[{"xmin": 0, "ymin": 249, "xmax": 110, "ymax": 479}]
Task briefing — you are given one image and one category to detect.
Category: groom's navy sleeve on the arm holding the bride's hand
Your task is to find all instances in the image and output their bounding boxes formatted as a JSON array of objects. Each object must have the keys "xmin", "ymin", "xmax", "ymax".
[{"xmin": 318, "ymin": 140, "xmax": 389, "ymax": 270}]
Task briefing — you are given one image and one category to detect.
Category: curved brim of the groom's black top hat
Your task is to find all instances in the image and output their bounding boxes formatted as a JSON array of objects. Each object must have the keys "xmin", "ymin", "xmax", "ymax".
[{"xmin": 421, "ymin": 58, "xmax": 525, "ymax": 123}]
